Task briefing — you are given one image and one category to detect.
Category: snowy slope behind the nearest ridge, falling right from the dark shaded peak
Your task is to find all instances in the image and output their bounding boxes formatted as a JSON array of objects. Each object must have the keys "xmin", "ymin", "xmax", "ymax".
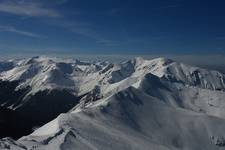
[{"xmin": 139, "ymin": 74, "xmax": 225, "ymax": 118}]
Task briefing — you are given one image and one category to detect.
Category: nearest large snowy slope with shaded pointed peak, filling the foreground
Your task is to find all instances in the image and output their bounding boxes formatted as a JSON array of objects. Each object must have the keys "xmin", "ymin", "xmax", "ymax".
[{"xmin": 2, "ymin": 87, "xmax": 225, "ymax": 150}]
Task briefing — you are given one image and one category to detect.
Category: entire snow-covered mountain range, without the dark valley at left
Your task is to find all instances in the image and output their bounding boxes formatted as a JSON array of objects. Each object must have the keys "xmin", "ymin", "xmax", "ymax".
[{"xmin": 0, "ymin": 57, "xmax": 225, "ymax": 150}]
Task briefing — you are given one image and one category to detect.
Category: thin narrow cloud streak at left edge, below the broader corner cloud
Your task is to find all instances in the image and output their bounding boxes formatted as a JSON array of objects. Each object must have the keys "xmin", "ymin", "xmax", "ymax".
[{"xmin": 0, "ymin": 26, "xmax": 43, "ymax": 38}]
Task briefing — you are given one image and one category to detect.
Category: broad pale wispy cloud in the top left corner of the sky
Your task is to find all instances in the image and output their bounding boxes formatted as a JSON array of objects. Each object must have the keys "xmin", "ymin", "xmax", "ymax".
[{"xmin": 0, "ymin": 1, "xmax": 62, "ymax": 18}]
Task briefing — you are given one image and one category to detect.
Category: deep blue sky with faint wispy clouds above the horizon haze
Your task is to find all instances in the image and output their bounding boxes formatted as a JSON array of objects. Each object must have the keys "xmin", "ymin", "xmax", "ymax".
[{"xmin": 0, "ymin": 0, "xmax": 225, "ymax": 55}]
